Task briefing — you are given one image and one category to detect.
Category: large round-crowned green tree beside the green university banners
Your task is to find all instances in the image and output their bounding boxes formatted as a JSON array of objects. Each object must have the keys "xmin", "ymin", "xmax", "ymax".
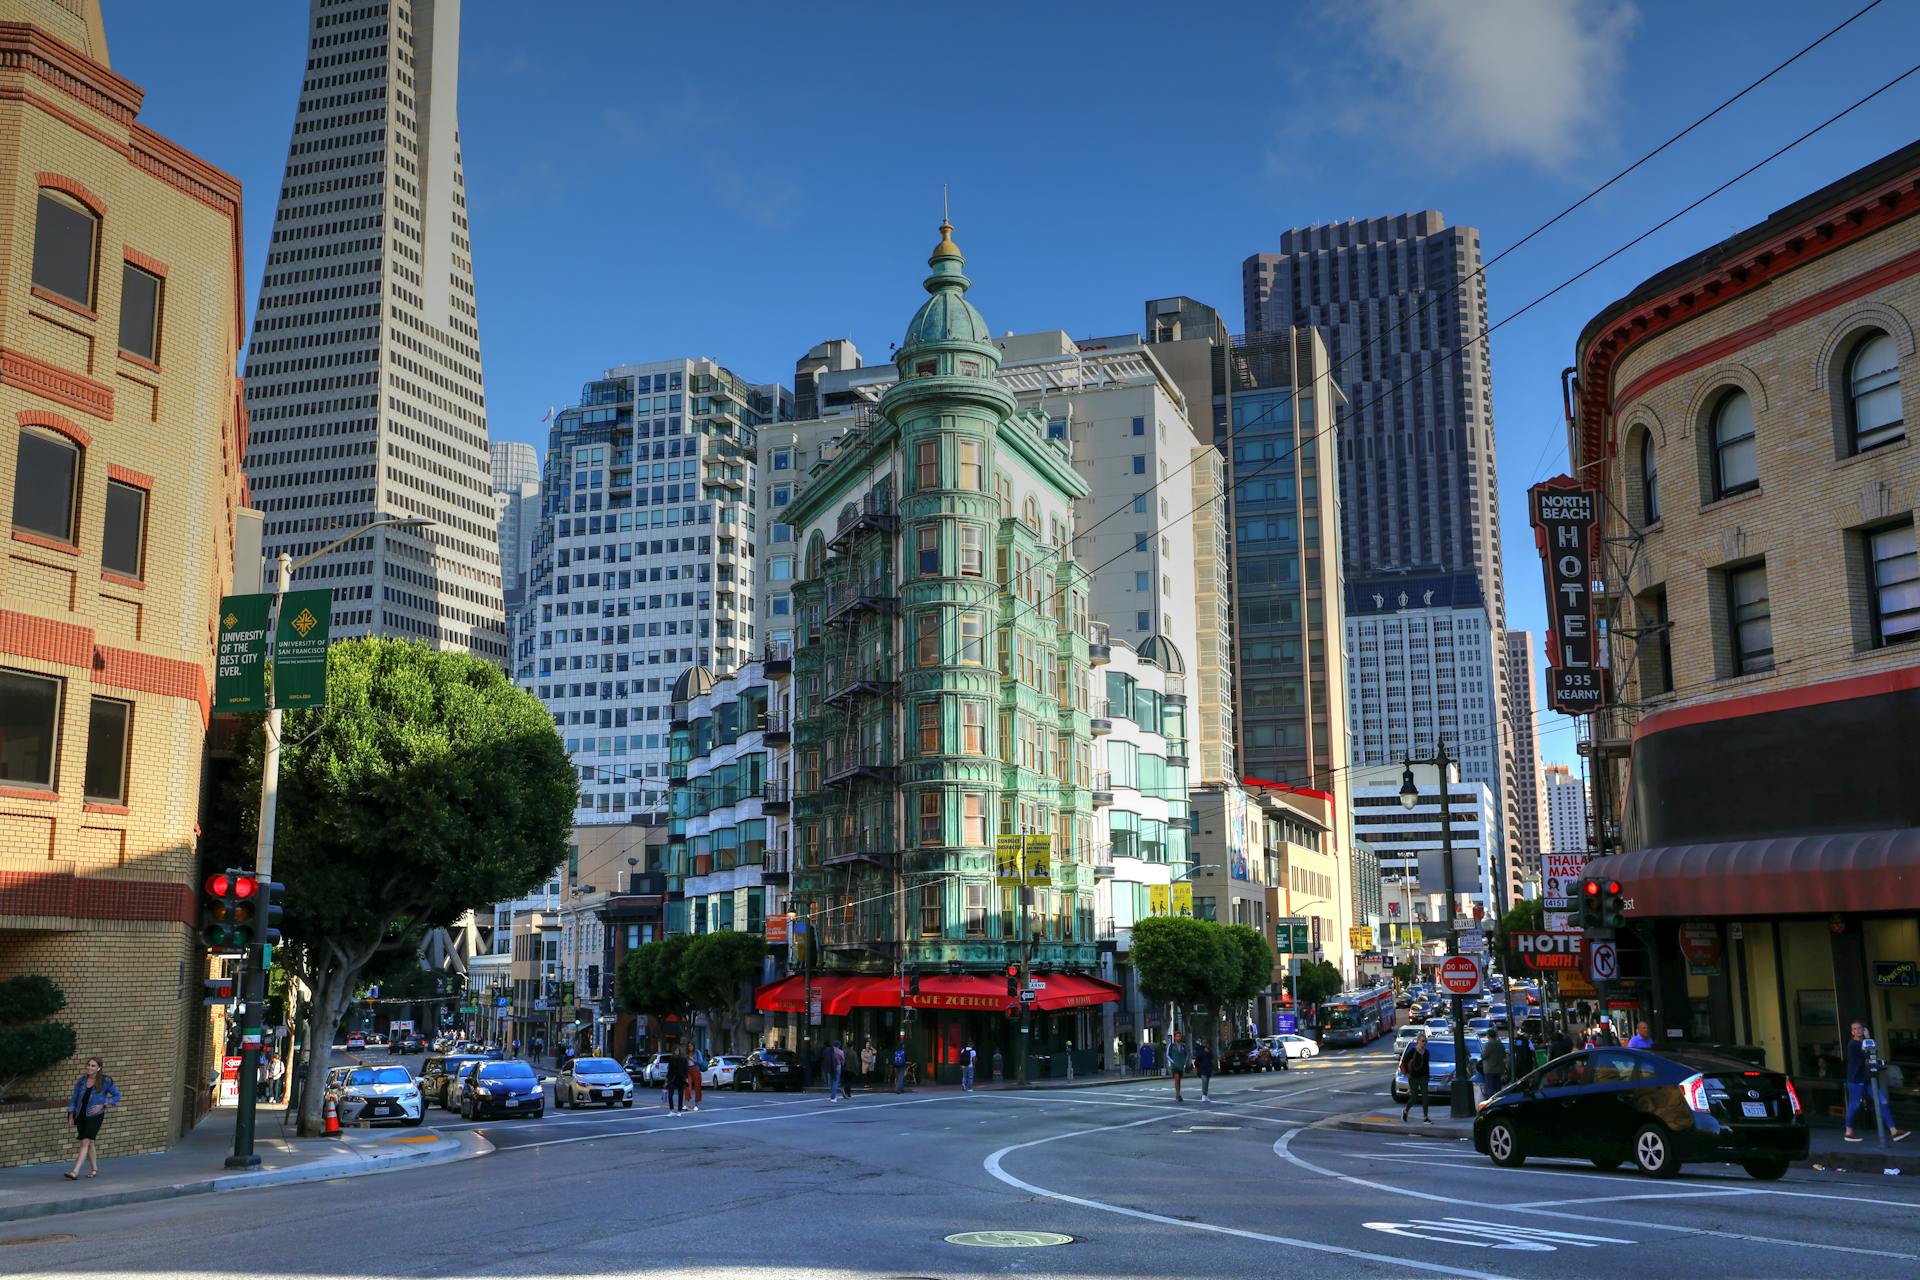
[{"xmin": 230, "ymin": 639, "xmax": 578, "ymax": 1134}]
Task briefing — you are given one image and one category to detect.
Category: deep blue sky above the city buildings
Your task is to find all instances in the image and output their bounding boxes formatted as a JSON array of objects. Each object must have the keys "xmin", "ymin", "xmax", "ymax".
[{"xmin": 104, "ymin": 0, "xmax": 1920, "ymax": 760}]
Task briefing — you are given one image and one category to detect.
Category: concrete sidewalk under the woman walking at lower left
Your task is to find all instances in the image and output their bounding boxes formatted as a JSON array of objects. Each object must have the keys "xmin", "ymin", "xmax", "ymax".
[{"xmin": 0, "ymin": 1107, "xmax": 493, "ymax": 1222}]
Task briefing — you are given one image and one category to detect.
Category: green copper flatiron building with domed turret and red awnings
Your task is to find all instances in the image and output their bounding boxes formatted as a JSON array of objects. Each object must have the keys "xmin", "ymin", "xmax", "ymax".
[{"xmin": 741, "ymin": 223, "xmax": 1117, "ymax": 1079}]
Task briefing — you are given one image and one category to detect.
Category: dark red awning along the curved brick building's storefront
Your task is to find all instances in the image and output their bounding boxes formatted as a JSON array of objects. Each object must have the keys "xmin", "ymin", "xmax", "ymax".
[{"xmin": 1588, "ymin": 827, "xmax": 1920, "ymax": 919}]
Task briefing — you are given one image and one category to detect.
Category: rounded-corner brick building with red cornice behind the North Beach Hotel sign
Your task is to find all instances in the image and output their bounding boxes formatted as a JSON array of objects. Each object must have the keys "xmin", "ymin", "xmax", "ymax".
[{"xmin": 1571, "ymin": 144, "xmax": 1920, "ymax": 1105}]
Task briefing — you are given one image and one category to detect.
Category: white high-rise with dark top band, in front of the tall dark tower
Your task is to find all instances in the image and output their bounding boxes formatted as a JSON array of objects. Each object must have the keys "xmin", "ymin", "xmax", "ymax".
[{"xmin": 1346, "ymin": 574, "xmax": 1521, "ymax": 898}]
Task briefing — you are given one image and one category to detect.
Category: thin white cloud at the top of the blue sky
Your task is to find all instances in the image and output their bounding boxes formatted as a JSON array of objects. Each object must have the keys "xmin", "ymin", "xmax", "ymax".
[{"xmin": 1336, "ymin": 0, "xmax": 1640, "ymax": 169}]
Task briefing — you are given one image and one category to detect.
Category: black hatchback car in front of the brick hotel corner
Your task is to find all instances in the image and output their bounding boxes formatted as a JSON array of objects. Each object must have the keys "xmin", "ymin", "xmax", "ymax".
[{"xmin": 1473, "ymin": 1048, "xmax": 1807, "ymax": 1180}]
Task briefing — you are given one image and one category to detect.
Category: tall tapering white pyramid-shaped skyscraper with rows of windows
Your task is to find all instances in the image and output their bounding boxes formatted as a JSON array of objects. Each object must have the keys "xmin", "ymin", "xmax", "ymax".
[{"xmin": 246, "ymin": 0, "xmax": 507, "ymax": 664}]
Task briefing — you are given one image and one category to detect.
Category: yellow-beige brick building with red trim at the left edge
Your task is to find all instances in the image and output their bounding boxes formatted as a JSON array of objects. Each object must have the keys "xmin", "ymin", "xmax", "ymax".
[{"xmin": 0, "ymin": 0, "xmax": 248, "ymax": 1165}]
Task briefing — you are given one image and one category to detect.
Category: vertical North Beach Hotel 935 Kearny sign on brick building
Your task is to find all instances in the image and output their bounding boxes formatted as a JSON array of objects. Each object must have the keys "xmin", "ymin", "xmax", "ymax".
[{"xmin": 1526, "ymin": 476, "xmax": 1605, "ymax": 716}]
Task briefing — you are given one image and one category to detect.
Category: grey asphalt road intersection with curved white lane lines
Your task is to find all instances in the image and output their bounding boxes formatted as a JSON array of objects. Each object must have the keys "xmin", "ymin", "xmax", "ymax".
[{"xmin": 18, "ymin": 1048, "xmax": 1920, "ymax": 1280}]
